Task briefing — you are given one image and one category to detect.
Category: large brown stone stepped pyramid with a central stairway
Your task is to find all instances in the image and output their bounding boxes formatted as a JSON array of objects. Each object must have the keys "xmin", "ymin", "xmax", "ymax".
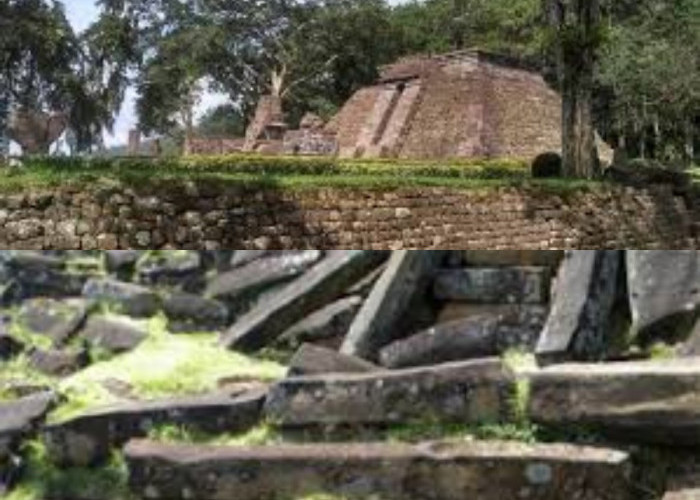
[{"xmin": 326, "ymin": 51, "xmax": 561, "ymax": 159}]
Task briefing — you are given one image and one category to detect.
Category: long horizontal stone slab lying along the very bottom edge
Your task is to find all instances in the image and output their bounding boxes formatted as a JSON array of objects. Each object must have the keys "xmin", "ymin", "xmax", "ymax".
[{"xmin": 126, "ymin": 441, "xmax": 631, "ymax": 500}]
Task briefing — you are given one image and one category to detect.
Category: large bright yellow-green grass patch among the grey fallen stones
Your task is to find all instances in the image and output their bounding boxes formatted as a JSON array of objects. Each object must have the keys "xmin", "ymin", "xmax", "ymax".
[{"xmin": 50, "ymin": 316, "xmax": 285, "ymax": 422}]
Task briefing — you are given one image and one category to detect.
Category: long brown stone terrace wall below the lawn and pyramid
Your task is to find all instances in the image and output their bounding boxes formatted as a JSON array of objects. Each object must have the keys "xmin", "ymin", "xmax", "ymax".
[{"xmin": 0, "ymin": 182, "xmax": 699, "ymax": 250}]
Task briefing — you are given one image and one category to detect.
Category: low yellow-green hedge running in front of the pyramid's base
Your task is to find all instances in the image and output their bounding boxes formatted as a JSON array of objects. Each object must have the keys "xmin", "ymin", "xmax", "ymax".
[{"xmin": 12, "ymin": 154, "xmax": 530, "ymax": 179}]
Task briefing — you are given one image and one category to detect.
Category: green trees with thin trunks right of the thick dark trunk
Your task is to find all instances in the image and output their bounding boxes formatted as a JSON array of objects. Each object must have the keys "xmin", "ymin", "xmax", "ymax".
[{"xmin": 600, "ymin": 0, "xmax": 700, "ymax": 164}]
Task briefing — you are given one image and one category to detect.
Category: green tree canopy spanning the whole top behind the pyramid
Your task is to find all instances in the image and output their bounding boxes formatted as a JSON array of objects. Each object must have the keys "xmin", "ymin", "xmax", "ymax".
[{"xmin": 0, "ymin": 0, "xmax": 700, "ymax": 168}]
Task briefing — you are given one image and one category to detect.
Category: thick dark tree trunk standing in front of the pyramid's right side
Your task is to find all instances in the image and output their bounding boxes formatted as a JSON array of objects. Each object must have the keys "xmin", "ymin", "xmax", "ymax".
[{"xmin": 547, "ymin": 0, "xmax": 600, "ymax": 179}]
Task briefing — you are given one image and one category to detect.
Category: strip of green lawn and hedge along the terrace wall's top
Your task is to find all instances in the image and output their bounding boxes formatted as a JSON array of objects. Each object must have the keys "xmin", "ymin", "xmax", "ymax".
[{"xmin": 0, "ymin": 155, "xmax": 595, "ymax": 192}]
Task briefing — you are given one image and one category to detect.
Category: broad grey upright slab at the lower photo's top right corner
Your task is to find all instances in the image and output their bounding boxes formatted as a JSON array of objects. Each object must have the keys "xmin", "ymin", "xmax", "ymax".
[{"xmin": 626, "ymin": 250, "xmax": 700, "ymax": 336}]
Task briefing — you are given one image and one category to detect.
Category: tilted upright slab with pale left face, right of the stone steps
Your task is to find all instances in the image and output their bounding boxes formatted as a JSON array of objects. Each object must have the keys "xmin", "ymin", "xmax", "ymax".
[{"xmin": 537, "ymin": 250, "xmax": 622, "ymax": 362}]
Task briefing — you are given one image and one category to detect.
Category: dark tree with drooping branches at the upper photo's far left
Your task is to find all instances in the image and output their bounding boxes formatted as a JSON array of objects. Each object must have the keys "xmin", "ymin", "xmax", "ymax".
[{"xmin": 0, "ymin": 0, "xmax": 123, "ymax": 153}]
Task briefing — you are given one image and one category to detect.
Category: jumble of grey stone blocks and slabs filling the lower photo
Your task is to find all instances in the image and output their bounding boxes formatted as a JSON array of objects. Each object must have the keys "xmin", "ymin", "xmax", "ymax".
[{"xmin": 0, "ymin": 250, "xmax": 700, "ymax": 500}]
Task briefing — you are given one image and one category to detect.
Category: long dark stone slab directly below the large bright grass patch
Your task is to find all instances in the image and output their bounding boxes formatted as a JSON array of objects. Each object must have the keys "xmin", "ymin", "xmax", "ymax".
[{"xmin": 45, "ymin": 391, "xmax": 265, "ymax": 466}]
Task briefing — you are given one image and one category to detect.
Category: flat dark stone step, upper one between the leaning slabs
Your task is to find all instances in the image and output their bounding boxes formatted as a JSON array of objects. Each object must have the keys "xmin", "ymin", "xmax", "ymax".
[{"xmin": 434, "ymin": 267, "xmax": 552, "ymax": 304}]
